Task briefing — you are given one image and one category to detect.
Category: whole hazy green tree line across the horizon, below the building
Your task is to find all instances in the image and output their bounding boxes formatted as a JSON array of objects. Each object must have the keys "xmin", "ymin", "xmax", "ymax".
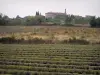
[{"xmin": 0, "ymin": 12, "xmax": 100, "ymax": 27}]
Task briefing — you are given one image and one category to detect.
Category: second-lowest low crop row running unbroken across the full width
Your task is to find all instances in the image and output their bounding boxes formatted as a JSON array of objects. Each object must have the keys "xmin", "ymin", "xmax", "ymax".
[{"xmin": 0, "ymin": 62, "xmax": 100, "ymax": 70}]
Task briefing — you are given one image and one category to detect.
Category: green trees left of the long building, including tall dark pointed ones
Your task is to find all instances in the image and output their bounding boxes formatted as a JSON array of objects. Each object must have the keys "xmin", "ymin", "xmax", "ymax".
[{"xmin": 0, "ymin": 12, "xmax": 45, "ymax": 26}]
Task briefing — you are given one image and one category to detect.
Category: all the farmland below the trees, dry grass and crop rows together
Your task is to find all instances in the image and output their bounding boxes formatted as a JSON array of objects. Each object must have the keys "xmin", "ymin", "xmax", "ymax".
[{"xmin": 0, "ymin": 26, "xmax": 100, "ymax": 75}]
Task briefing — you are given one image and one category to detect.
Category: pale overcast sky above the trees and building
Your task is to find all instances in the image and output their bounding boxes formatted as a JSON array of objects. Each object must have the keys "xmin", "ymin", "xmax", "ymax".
[{"xmin": 0, "ymin": 0, "xmax": 100, "ymax": 18}]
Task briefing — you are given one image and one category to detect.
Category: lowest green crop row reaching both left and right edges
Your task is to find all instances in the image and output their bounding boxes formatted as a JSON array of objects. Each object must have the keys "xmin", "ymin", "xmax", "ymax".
[{"xmin": 0, "ymin": 65, "xmax": 100, "ymax": 74}]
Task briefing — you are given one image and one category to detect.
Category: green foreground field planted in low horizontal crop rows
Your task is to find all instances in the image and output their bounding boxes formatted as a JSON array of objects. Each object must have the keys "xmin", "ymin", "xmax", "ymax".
[{"xmin": 0, "ymin": 44, "xmax": 100, "ymax": 75}]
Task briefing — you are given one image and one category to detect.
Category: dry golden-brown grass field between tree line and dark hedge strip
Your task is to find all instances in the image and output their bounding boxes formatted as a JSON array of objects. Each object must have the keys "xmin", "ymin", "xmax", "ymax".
[{"xmin": 0, "ymin": 26, "xmax": 100, "ymax": 44}]
